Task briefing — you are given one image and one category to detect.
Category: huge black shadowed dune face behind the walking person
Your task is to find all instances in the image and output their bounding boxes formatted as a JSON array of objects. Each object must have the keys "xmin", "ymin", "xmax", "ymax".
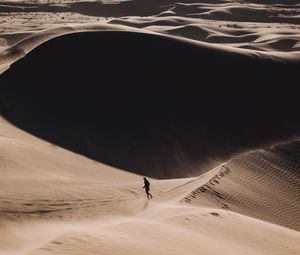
[{"xmin": 0, "ymin": 32, "xmax": 300, "ymax": 178}]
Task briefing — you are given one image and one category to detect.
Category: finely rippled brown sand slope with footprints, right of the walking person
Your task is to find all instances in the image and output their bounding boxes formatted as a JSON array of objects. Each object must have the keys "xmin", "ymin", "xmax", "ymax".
[{"xmin": 182, "ymin": 141, "xmax": 300, "ymax": 231}]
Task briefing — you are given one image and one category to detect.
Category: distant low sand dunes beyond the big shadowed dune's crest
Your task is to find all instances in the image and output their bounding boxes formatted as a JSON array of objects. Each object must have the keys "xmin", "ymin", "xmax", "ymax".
[{"xmin": 0, "ymin": 0, "xmax": 300, "ymax": 56}]
